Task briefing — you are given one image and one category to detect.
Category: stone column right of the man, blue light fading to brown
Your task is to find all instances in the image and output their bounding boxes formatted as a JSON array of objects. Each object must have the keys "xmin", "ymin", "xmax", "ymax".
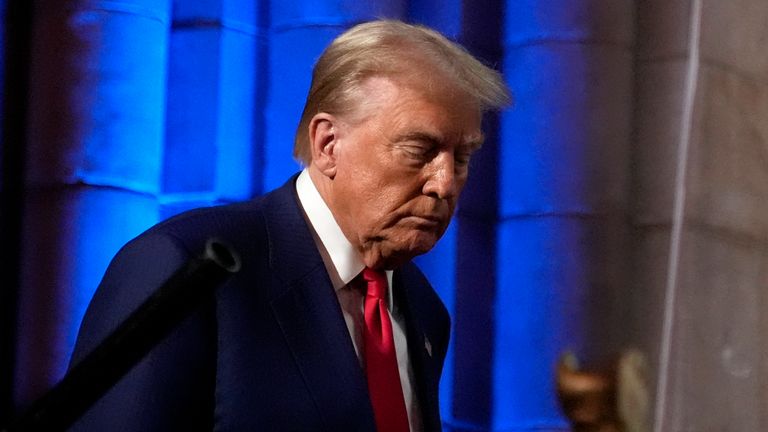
[{"xmin": 493, "ymin": 0, "xmax": 634, "ymax": 430}]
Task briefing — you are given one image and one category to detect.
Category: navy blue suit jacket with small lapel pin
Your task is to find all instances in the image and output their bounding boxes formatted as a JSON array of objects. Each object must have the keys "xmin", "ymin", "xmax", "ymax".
[{"xmin": 72, "ymin": 176, "xmax": 449, "ymax": 431}]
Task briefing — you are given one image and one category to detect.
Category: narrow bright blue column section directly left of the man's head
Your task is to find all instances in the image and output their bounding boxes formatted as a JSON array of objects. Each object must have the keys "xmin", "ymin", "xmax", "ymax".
[{"xmin": 162, "ymin": 0, "xmax": 266, "ymax": 216}]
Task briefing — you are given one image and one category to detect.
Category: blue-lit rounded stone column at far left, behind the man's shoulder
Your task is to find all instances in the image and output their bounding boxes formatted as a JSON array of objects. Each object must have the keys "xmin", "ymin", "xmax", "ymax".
[{"xmin": 16, "ymin": 0, "xmax": 169, "ymax": 405}]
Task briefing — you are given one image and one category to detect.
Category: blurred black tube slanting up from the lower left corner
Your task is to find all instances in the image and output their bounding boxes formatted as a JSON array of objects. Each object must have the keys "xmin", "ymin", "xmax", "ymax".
[{"xmin": 3, "ymin": 239, "xmax": 241, "ymax": 432}]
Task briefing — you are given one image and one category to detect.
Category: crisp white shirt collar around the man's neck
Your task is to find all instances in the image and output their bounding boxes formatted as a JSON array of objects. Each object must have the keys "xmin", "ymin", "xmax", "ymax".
[{"xmin": 296, "ymin": 168, "xmax": 393, "ymax": 310}]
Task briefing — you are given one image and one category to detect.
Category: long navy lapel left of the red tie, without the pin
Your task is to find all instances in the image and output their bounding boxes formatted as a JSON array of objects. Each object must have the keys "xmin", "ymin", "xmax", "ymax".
[{"xmin": 265, "ymin": 177, "xmax": 374, "ymax": 430}]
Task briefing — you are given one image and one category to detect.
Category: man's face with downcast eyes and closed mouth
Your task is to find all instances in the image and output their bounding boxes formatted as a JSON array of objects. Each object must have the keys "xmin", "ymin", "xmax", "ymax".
[{"xmin": 322, "ymin": 77, "xmax": 482, "ymax": 268}]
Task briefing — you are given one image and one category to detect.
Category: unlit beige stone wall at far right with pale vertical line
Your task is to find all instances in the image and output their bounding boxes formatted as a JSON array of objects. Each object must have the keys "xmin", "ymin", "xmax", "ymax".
[{"xmin": 628, "ymin": 0, "xmax": 768, "ymax": 431}]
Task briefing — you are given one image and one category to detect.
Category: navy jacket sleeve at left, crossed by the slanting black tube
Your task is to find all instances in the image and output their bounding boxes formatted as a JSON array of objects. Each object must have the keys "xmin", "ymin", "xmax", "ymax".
[{"xmin": 71, "ymin": 233, "xmax": 216, "ymax": 431}]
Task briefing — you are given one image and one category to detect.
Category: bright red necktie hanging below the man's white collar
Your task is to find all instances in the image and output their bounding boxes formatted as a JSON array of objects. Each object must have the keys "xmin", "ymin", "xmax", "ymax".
[{"xmin": 363, "ymin": 268, "xmax": 410, "ymax": 432}]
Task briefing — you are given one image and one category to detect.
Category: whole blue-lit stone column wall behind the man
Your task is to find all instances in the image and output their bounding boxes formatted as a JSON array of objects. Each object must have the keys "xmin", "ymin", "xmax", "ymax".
[{"xmin": 7, "ymin": 0, "xmax": 632, "ymax": 431}]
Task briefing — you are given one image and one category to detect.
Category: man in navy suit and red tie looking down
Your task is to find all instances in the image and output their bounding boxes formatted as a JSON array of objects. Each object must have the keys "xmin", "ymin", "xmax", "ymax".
[{"xmin": 73, "ymin": 21, "xmax": 508, "ymax": 431}]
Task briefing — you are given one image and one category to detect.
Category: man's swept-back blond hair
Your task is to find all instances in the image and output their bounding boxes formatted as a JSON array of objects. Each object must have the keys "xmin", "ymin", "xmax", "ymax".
[{"xmin": 293, "ymin": 20, "xmax": 510, "ymax": 165}]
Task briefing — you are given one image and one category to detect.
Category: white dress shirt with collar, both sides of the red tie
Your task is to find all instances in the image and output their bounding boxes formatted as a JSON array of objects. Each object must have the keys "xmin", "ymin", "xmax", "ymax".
[{"xmin": 296, "ymin": 169, "xmax": 422, "ymax": 431}]
